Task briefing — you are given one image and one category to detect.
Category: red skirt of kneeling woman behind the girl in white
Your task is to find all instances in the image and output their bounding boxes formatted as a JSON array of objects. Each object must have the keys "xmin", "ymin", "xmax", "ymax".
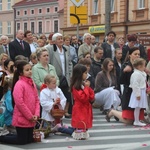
[{"xmin": 122, "ymin": 109, "xmax": 144, "ymax": 120}]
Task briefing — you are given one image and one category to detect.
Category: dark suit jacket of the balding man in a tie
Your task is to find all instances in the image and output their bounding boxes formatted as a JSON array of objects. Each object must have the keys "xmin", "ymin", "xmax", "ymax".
[{"xmin": 9, "ymin": 39, "xmax": 31, "ymax": 61}]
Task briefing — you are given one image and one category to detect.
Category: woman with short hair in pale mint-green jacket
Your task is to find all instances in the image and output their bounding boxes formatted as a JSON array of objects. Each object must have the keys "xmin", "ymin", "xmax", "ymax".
[{"xmin": 32, "ymin": 47, "xmax": 59, "ymax": 91}]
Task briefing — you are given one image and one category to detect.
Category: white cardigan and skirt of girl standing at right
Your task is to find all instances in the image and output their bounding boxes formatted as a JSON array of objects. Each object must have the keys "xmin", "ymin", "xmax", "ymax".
[{"xmin": 129, "ymin": 69, "xmax": 148, "ymax": 108}]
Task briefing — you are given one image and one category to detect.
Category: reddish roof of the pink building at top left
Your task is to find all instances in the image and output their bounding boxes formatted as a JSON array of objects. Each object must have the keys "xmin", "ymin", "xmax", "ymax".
[{"xmin": 13, "ymin": 0, "xmax": 58, "ymax": 7}]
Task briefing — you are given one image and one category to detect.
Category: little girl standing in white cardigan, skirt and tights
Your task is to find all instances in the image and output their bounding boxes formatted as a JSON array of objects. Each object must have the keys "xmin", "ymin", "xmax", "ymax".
[{"xmin": 129, "ymin": 58, "xmax": 148, "ymax": 126}]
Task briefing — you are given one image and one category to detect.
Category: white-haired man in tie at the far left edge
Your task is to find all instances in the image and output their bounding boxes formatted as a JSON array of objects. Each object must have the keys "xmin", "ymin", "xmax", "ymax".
[{"xmin": 0, "ymin": 35, "xmax": 10, "ymax": 56}]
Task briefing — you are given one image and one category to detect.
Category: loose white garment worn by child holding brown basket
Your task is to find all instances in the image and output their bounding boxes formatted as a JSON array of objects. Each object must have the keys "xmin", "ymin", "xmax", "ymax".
[{"xmin": 40, "ymin": 87, "xmax": 66, "ymax": 121}]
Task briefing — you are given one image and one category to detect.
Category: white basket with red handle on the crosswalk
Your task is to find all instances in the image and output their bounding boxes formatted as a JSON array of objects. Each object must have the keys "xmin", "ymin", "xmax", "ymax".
[{"xmin": 72, "ymin": 121, "xmax": 90, "ymax": 140}]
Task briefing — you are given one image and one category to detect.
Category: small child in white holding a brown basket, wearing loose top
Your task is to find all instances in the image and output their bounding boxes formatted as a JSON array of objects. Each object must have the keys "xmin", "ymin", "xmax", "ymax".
[{"xmin": 40, "ymin": 74, "xmax": 66, "ymax": 126}]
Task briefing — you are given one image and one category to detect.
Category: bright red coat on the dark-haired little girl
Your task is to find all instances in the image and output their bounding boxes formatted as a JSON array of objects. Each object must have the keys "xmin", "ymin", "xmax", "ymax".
[{"xmin": 71, "ymin": 87, "xmax": 94, "ymax": 129}]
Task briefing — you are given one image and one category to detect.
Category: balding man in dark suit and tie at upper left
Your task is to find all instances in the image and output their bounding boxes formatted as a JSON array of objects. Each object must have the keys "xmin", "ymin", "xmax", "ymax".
[{"xmin": 9, "ymin": 30, "xmax": 31, "ymax": 60}]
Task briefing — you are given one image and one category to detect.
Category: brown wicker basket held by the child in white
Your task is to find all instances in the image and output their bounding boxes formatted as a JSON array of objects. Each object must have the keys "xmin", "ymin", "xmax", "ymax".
[{"xmin": 51, "ymin": 104, "xmax": 65, "ymax": 119}]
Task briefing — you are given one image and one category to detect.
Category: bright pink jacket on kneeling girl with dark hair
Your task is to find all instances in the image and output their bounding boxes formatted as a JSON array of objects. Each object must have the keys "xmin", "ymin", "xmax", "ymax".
[{"xmin": 12, "ymin": 76, "xmax": 40, "ymax": 128}]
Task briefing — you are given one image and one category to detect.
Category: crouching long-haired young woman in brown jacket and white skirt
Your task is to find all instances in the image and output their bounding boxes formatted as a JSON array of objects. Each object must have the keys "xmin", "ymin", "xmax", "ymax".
[{"xmin": 95, "ymin": 58, "xmax": 121, "ymax": 114}]
